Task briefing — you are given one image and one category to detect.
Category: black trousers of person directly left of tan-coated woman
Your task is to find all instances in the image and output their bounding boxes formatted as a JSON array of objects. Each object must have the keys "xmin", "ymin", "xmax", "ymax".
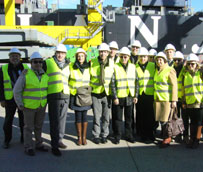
[{"xmin": 136, "ymin": 93, "xmax": 155, "ymax": 139}]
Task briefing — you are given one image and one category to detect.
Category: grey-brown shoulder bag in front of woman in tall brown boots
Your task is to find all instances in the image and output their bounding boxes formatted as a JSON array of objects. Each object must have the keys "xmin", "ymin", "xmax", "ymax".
[{"xmin": 75, "ymin": 86, "xmax": 92, "ymax": 106}]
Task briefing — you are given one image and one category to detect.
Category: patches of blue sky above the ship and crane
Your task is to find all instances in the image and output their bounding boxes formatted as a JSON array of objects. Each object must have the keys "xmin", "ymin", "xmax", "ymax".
[{"xmin": 48, "ymin": 0, "xmax": 203, "ymax": 12}]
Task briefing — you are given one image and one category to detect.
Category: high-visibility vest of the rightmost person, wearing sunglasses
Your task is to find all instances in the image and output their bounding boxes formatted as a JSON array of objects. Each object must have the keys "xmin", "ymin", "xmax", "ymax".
[{"xmin": 184, "ymin": 71, "xmax": 203, "ymax": 104}]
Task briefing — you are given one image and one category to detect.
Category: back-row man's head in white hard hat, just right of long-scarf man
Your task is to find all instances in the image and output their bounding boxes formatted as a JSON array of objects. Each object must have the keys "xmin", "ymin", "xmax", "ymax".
[{"xmin": 109, "ymin": 41, "xmax": 119, "ymax": 64}]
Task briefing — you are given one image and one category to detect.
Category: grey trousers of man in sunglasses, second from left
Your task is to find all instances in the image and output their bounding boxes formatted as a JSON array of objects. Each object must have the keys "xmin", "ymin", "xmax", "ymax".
[{"xmin": 23, "ymin": 106, "xmax": 46, "ymax": 150}]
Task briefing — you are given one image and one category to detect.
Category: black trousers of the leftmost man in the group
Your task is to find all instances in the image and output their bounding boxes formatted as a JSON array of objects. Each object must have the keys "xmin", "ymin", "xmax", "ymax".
[{"xmin": 3, "ymin": 103, "xmax": 24, "ymax": 143}]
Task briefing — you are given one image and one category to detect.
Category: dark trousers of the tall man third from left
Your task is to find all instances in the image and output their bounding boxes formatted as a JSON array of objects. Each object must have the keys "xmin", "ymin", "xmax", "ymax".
[{"xmin": 48, "ymin": 99, "xmax": 69, "ymax": 148}]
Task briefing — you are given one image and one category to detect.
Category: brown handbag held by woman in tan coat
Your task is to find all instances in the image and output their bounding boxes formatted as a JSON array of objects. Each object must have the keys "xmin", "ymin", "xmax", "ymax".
[{"xmin": 165, "ymin": 107, "xmax": 185, "ymax": 137}]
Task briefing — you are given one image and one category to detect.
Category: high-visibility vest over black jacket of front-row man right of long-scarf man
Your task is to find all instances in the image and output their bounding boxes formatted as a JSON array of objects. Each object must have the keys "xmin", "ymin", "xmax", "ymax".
[{"xmin": 114, "ymin": 63, "xmax": 136, "ymax": 98}]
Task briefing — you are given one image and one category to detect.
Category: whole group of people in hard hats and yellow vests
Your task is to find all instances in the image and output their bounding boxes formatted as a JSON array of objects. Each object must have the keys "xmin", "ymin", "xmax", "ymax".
[{"xmin": 0, "ymin": 40, "xmax": 203, "ymax": 156}]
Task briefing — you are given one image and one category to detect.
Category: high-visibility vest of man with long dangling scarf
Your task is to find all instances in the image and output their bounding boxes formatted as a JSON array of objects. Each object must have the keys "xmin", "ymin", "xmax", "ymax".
[{"xmin": 90, "ymin": 59, "xmax": 114, "ymax": 95}]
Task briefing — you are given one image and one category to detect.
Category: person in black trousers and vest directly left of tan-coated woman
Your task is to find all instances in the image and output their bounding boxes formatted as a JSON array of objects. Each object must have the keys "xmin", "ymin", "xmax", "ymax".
[{"xmin": 136, "ymin": 47, "xmax": 156, "ymax": 143}]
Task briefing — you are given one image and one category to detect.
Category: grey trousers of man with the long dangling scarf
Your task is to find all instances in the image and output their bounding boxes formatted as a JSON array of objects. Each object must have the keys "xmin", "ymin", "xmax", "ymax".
[{"xmin": 92, "ymin": 96, "xmax": 110, "ymax": 138}]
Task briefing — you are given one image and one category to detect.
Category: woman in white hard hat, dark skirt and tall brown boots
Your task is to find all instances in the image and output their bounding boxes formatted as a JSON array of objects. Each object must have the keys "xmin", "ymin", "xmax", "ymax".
[{"xmin": 69, "ymin": 48, "xmax": 91, "ymax": 145}]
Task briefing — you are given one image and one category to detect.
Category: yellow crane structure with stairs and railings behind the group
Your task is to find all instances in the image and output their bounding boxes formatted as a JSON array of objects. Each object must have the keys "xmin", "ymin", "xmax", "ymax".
[{"xmin": 0, "ymin": 0, "xmax": 104, "ymax": 50}]
